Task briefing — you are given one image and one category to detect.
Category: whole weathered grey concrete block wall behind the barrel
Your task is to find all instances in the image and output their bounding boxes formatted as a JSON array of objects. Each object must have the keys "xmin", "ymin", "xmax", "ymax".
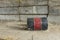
[{"xmin": 0, "ymin": 0, "xmax": 60, "ymax": 21}]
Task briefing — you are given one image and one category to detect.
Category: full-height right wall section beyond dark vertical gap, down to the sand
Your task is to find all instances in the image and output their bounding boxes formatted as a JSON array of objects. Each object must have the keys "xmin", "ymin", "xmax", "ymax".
[{"xmin": 48, "ymin": 0, "xmax": 60, "ymax": 24}]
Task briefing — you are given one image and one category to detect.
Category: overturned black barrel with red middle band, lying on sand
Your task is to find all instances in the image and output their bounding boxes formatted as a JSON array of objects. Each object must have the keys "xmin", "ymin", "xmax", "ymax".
[{"xmin": 27, "ymin": 17, "xmax": 48, "ymax": 30}]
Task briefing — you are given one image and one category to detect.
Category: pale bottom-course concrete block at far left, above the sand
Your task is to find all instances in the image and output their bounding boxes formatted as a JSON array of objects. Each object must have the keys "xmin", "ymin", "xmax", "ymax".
[{"xmin": 0, "ymin": 15, "xmax": 19, "ymax": 21}]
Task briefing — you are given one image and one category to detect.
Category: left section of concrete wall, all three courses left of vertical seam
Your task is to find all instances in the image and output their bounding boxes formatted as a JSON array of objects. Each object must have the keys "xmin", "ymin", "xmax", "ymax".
[{"xmin": 0, "ymin": 0, "xmax": 19, "ymax": 21}]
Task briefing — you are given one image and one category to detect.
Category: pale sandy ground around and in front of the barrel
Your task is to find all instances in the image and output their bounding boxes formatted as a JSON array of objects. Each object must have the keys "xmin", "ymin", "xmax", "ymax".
[{"xmin": 0, "ymin": 22, "xmax": 60, "ymax": 40}]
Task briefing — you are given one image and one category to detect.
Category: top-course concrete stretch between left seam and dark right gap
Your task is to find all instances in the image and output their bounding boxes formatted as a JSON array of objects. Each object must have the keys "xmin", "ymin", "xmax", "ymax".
[{"xmin": 20, "ymin": 0, "xmax": 47, "ymax": 6}]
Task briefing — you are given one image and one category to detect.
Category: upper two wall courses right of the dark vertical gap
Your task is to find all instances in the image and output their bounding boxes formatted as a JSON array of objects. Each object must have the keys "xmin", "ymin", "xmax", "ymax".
[{"xmin": 49, "ymin": 0, "xmax": 60, "ymax": 16}]
